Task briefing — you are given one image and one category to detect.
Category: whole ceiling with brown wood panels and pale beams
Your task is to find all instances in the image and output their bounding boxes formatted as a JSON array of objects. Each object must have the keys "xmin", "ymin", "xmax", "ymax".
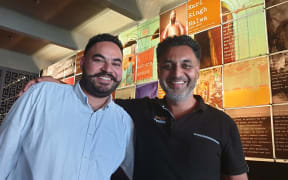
[{"xmin": 0, "ymin": 0, "xmax": 185, "ymax": 69}]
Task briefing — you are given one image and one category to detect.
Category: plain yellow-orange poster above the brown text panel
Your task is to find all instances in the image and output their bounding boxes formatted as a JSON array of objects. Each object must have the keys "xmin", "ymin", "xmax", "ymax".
[{"xmin": 223, "ymin": 57, "xmax": 270, "ymax": 108}]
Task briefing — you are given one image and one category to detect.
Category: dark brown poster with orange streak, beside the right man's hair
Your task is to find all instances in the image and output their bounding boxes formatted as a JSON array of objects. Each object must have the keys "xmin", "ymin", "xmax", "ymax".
[{"xmin": 194, "ymin": 26, "xmax": 222, "ymax": 69}]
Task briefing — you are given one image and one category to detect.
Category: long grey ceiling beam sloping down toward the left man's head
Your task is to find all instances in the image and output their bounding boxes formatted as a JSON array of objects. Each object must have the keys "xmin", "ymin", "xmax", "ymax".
[{"xmin": 0, "ymin": 7, "xmax": 88, "ymax": 50}]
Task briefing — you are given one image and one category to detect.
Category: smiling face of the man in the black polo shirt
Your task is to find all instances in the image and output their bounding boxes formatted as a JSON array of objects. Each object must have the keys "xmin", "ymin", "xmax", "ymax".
[{"xmin": 158, "ymin": 45, "xmax": 199, "ymax": 102}]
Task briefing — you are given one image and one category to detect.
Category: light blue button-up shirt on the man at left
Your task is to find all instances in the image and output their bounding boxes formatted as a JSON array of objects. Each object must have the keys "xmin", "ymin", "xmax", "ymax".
[{"xmin": 0, "ymin": 82, "xmax": 133, "ymax": 180}]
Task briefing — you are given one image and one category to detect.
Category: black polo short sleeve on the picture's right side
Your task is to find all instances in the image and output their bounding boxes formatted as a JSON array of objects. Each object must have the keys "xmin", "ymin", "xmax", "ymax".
[{"xmin": 222, "ymin": 119, "xmax": 248, "ymax": 176}]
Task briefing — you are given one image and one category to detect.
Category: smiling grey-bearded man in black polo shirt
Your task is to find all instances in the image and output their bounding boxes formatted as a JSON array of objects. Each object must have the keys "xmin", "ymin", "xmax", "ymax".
[{"xmin": 19, "ymin": 35, "xmax": 248, "ymax": 180}]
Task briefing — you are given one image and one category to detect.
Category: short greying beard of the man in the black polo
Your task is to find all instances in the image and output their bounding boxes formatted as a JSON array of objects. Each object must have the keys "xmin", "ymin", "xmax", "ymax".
[{"xmin": 159, "ymin": 78, "xmax": 197, "ymax": 103}]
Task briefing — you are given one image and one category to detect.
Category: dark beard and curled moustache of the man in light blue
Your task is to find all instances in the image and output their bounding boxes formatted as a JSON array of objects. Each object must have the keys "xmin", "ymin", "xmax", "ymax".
[{"xmin": 80, "ymin": 68, "xmax": 121, "ymax": 98}]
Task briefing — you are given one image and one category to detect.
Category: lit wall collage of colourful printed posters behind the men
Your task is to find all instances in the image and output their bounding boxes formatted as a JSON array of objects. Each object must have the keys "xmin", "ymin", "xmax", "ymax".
[{"xmin": 42, "ymin": 0, "xmax": 288, "ymax": 163}]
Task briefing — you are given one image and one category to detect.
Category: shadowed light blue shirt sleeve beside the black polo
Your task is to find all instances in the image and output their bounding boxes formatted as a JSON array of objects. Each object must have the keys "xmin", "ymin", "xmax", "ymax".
[{"xmin": 121, "ymin": 115, "xmax": 134, "ymax": 180}]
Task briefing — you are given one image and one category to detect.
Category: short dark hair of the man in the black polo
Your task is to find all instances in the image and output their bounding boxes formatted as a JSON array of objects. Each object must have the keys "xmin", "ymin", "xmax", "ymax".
[{"xmin": 157, "ymin": 35, "xmax": 201, "ymax": 63}]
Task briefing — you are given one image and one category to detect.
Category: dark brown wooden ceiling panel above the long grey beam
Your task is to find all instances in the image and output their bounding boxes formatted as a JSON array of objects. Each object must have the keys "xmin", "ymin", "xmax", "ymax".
[{"xmin": 0, "ymin": 0, "xmax": 107, "ymax": 30}]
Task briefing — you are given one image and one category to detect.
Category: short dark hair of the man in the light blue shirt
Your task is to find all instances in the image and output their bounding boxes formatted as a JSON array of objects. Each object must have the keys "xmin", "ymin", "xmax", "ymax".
[{"xmin": 84, "ymin": 33, "xmax": 123, "ymax": 56}]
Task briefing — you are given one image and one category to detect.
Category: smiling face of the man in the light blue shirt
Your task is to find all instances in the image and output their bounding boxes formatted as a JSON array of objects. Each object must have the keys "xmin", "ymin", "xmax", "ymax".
[{"xmin": 80, "ymin": 41, "xmax": 123, "ymax": 97}]
